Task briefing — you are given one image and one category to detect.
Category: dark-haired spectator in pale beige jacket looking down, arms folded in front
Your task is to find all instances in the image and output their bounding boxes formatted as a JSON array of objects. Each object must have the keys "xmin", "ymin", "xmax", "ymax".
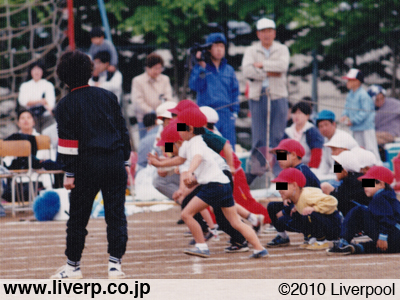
[{"xmin": 131, "ymin": 53, "xmax": 173, "ymax": 139}]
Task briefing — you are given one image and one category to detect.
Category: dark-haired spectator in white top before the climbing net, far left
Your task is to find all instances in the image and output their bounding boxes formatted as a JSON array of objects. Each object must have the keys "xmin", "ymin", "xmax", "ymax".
[{"xmin": 18, "ymin": 61, "xmax": 56, "ymax": 133}]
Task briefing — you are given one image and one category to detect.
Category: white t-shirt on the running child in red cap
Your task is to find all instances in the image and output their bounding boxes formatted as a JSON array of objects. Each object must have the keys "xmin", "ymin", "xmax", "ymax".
[{"xmin": 179, "ymin": 135, "xmax": 229, "ymax": 184}]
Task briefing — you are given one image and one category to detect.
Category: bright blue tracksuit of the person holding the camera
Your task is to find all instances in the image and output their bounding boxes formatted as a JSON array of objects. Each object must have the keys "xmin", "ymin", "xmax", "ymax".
[{"xmin": 189, "ymin": 58, "xmax": 239, "ymax": 147}]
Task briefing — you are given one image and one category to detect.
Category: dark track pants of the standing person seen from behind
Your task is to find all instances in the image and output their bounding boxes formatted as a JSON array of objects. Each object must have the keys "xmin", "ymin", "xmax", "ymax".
[{"xmin": 65, "ymin": 150, "xmax": 128, "ymax": 261}]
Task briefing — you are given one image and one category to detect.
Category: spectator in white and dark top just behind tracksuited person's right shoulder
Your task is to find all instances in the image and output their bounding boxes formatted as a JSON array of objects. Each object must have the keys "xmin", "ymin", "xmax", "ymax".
[{"xmin": 89, "ymin": 51, "xmax": 122, "ymax": 104}]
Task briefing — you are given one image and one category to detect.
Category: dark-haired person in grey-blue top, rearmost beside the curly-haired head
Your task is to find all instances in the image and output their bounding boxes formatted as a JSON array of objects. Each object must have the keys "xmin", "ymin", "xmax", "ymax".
[{"xmin": 88, "ymin": 27, "xmax": 118, "ymax": 73}]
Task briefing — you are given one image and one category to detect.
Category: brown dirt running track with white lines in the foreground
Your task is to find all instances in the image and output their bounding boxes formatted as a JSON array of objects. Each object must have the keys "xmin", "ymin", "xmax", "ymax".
[{"xmin": 0, "ymin": 206, "xmax": 400, "ymax": 279}]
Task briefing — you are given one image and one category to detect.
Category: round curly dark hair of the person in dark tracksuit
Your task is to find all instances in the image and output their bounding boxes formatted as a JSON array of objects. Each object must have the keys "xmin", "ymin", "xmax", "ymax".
[{"xmin": 57, "ymin": 50, "xmax": 93, "ymax": 89}]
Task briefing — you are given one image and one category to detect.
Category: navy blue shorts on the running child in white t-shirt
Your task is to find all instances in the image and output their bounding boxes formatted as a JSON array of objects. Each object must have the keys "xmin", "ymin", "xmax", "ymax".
[{"xmin": 196, "ymin": 182, "xmax": 235, "ymax": 207}]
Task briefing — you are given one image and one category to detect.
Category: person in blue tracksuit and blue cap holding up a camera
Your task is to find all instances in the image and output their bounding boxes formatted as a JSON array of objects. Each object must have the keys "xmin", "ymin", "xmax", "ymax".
[{"xmin": 189, "ymin": 33, "xmax": 240, "ymax": 150}]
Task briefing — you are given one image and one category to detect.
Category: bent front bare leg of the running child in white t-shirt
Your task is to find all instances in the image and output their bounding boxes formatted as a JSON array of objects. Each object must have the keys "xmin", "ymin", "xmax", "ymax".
[{"xmin": 181, "ymin": 197, "xmax": 208, "ymax": 244}]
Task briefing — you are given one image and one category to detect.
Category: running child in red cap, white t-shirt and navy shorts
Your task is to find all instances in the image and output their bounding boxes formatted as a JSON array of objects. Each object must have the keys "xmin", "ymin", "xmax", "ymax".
[{"xmin": 149, "ymin": 108, "xmax": 268, "ymax": 258}]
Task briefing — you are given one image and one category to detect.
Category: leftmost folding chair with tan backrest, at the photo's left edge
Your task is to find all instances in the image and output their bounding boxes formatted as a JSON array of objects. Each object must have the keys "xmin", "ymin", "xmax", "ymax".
[{"xmin": 0, "ymin": 140, "xmax": 34, "ymax": 217}]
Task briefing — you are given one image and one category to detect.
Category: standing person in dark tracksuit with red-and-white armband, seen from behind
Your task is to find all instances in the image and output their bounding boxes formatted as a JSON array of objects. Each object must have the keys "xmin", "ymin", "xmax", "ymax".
[{"xmin": 51, "ymin": 51, "xmax": 131, "ymax": 279}]
